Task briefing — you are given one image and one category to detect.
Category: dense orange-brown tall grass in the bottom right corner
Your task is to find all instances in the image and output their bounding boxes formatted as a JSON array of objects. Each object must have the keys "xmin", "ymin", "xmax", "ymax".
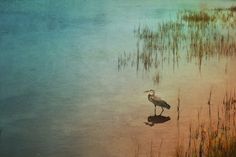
[{"xmin": 175, "ymin": 89, "xmax": 236, "ymax": 157}]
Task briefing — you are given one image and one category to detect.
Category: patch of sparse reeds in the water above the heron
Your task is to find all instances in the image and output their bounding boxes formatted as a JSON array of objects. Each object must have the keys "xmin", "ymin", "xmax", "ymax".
[{"xmin": 118, "ymin": 6, "xmax": 236, "ymax": 82}]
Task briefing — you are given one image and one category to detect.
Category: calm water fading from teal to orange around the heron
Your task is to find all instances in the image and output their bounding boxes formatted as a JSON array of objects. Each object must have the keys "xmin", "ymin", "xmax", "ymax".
[{"xmin": 0, "ymin": 0, "xmax": 236, "ymax": 157}]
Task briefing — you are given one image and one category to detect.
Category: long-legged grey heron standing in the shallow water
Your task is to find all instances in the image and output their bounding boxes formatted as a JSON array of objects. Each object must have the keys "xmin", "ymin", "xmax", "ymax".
[{"xmin": 145, "ymin": 89, "xmax": 170, "ymax": 115}]
